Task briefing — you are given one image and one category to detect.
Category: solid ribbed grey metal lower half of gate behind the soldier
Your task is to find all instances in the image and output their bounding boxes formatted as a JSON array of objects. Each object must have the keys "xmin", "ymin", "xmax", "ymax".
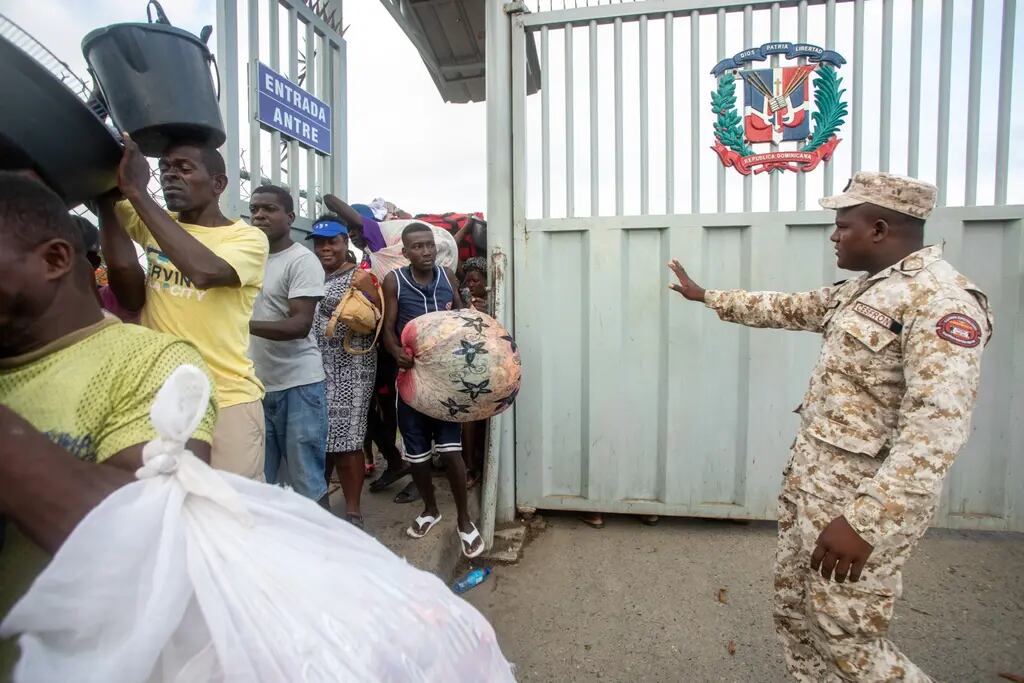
[{"xmin": 515, "ymin": 206, "xmax": 1024, "ymax": 530}]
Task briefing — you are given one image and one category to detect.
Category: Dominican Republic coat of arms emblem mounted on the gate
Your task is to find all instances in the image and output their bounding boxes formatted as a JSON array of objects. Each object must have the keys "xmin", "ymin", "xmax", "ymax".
[{"xmin": 711, "ymin": 42, "xmax": 847, "ymax": 175}]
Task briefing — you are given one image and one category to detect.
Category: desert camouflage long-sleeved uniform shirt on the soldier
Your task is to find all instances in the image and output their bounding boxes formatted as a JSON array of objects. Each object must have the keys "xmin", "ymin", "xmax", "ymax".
[{"xmin": 706, "ymin": 245, "xmax": 992, "ymax": 547}]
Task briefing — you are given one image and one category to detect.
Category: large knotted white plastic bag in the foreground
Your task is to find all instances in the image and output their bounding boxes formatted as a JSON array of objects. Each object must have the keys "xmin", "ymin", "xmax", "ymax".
[{"xmin": 0, "ymin": 366, "xmax": 513, "ymax": 683}]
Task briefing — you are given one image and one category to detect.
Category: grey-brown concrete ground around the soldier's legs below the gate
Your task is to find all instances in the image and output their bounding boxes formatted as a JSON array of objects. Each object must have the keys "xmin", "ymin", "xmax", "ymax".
[{"xmin": 466, "ymin": 515, "xmax": 1024, "ymax": 683}]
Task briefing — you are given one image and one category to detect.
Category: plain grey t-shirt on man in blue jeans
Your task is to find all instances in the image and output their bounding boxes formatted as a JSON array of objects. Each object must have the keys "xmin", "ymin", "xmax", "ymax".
[{"xmin": 249, "ymin": 244, "xmax": 324, "ymax": 391}]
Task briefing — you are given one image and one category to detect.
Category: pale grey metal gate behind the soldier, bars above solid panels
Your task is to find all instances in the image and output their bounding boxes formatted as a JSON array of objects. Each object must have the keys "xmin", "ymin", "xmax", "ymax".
[{"xmin": 487, "ymin": 0, "xmax": 1024, "ymax": 530}]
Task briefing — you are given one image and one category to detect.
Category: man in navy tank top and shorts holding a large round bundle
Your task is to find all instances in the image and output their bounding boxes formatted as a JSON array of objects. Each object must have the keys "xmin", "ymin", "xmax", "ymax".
[{"xmin": 384, "ymin": 223, "xmax": 483, "ymax": 558}]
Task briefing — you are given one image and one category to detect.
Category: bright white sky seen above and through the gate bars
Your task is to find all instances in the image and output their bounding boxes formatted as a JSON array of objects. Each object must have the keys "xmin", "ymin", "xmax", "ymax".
[{"xmin": 0, "ymin": 0, "xmax": 1024, "ymax": 217}]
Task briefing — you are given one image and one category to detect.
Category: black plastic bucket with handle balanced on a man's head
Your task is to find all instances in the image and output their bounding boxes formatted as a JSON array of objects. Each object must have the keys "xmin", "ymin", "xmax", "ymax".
[{"xmin": 82, "ymin": 24, "xmax": 227, "ymax": 157}]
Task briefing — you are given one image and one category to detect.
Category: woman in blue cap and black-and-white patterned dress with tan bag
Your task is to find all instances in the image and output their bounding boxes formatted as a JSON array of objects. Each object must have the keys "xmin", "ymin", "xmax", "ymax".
[{"xmin": 310, "ymin": 215, "xmax": 380, "ymax": 528}]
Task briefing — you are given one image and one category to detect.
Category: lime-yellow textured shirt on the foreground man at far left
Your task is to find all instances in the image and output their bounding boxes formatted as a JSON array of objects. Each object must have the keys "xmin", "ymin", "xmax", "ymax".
[{"xmin": 0, "ymin": 317, "xmax": 217, "ymax": 681}]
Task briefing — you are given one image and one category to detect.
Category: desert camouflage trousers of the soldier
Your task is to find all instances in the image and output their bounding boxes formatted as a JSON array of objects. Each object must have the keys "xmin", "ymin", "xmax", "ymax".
[{"xmin": 774, "ymin": 437, "xmax": 933, "ymax": 683}]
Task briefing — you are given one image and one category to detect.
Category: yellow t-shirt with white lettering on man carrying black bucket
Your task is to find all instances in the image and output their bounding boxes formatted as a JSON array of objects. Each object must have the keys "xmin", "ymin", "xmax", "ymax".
[{"xmin": 117, "ymin": 202, "xmax": 269, "ymax": 408}]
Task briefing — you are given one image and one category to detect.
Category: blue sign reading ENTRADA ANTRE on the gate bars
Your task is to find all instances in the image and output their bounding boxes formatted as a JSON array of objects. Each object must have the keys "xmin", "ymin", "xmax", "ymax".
[{"xmin": 256, "ymin": 61, "xmax": 332, "ymax": 155}]
